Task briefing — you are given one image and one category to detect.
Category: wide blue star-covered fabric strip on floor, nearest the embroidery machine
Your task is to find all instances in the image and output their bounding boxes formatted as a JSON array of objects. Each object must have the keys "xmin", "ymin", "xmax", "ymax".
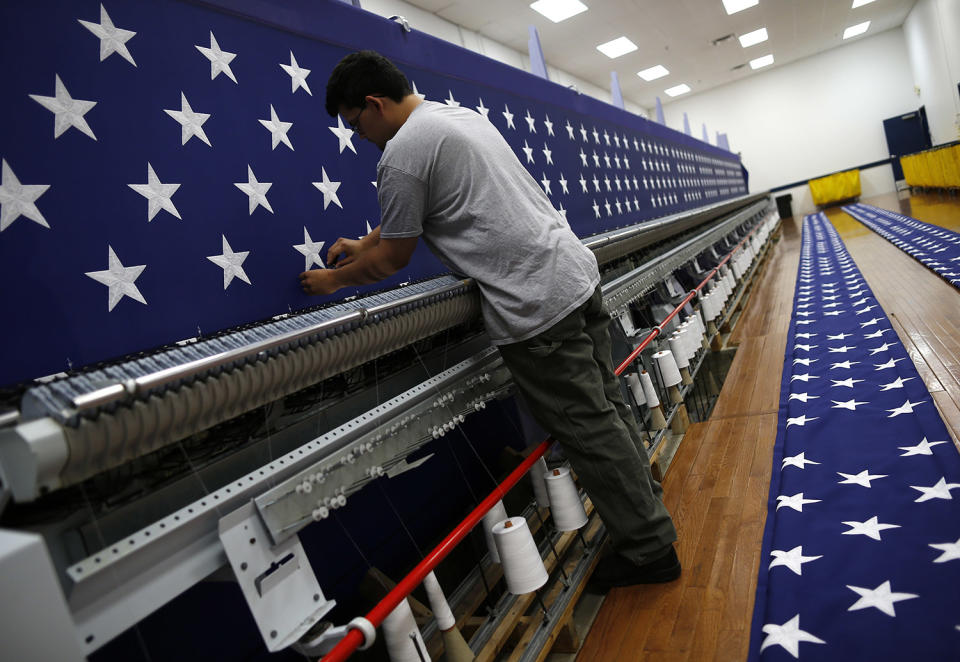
[{"xmin": 749, "ymin": 213, "xmax": 960, "ymax": 662}]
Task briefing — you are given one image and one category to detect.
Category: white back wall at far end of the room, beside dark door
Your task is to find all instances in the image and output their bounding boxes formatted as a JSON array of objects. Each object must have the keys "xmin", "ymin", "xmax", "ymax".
[{"xmin": 664, "ymin": 28, "xmax": 916, "ymax": 213}]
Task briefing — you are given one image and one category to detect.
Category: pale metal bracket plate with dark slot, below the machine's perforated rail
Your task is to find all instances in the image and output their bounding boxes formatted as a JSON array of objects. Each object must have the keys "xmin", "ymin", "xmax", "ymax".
[{"xmin": 219, "ymin": 502, "xmax": 337, "ymax": 652}]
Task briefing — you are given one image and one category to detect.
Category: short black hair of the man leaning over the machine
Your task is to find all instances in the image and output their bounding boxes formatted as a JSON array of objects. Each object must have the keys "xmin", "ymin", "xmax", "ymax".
[{"xmin": 326, "ymin": 51, "xmax": 412, "ymax": 117}]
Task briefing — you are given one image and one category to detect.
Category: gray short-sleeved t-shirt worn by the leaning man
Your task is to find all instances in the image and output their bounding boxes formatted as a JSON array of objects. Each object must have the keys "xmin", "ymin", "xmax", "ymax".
[{"xmin": 377, "ymin": 101, "xmax": 600, "ymax": 345}]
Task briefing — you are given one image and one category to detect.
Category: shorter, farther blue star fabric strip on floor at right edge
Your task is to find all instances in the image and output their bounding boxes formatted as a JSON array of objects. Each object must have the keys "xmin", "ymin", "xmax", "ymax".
[{"xmin": 843, "ymin": 203, "xmax": 960, "ymax": 287}]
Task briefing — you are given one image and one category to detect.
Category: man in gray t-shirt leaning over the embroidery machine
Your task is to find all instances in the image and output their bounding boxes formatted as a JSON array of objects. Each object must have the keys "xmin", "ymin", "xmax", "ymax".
[{"xmin": 300, "ymin": 51, "xmax": 680, "ymax": 587}]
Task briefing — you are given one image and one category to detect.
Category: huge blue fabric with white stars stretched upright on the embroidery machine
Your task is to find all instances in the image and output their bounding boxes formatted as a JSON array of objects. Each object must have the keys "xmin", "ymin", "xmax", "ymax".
[{"xmin": 0, "ymin": 0, "xmax": 746, "ymax": 386}]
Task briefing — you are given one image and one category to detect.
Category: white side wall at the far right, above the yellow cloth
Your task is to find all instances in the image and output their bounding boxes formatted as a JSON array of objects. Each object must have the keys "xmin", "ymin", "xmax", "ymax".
[{"xmin": 903, "ymin": 0, "xmax": 960, "ymax": 145}]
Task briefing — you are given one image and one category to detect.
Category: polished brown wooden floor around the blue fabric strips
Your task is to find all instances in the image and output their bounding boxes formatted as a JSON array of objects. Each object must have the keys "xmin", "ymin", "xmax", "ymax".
[{"xmin": 577, "ymin": 194, "xmax": 960, "ymax": 662}]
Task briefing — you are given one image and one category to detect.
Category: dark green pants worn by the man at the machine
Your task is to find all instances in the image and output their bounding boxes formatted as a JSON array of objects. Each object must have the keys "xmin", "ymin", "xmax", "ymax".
[{"xmin": 499, "ymin": 287, "xmax": 677, "ymax": 563}]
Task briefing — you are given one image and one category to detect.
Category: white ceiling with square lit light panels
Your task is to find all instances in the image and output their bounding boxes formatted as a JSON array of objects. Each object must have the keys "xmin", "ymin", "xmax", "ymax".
[{"xmin": 407, "ymin": 0, "xmax": 916, "ymax": 108}]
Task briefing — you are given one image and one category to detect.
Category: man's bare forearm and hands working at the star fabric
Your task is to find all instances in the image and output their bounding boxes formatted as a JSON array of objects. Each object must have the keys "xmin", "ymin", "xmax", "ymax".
[{"xmin": 300, "ymin": 235, "xmax": 419, "ymax": 294}]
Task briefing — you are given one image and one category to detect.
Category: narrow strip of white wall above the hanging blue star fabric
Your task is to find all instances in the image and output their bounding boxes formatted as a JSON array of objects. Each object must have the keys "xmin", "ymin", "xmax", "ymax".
[{"xmin": 360, "ymin": 0, "xmax": 649, "ymax": 117}]
